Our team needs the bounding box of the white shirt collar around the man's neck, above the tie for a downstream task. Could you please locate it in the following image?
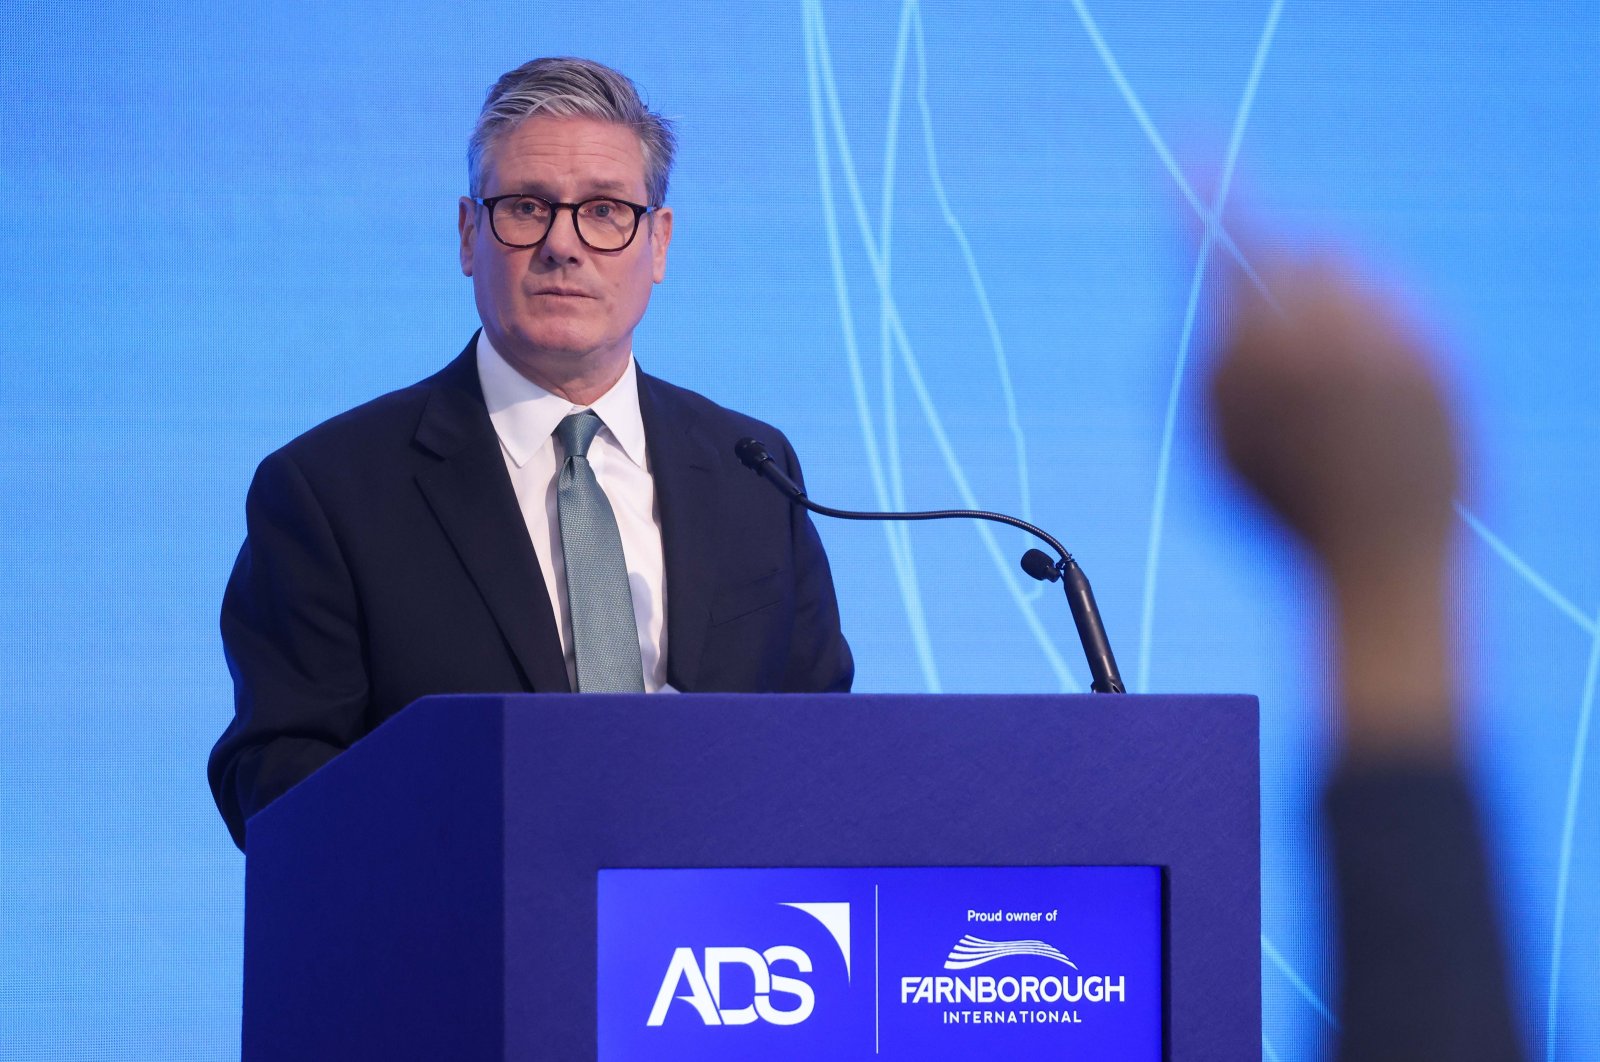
[477,331,646,469]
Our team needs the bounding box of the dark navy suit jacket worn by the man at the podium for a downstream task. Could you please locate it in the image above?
[210,339,854,848]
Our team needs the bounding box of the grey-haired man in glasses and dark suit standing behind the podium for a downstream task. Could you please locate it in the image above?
[210,59,853,848]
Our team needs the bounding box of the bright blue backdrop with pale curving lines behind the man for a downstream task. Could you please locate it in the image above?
[0,0,1600,1060]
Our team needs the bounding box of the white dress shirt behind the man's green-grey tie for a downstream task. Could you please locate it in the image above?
[478,333,670,693]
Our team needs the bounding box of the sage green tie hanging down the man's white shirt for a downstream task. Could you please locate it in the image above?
[555,409,645,693]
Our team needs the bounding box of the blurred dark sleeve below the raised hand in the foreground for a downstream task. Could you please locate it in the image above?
[1325,763,1522,1062]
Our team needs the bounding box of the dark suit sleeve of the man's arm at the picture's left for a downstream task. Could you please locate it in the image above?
[208,451,368,849]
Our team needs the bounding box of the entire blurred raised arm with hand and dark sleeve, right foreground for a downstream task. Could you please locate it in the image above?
[1211,264,1522,1062]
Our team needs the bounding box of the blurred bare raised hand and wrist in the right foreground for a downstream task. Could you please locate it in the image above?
[1210,259,1461,757]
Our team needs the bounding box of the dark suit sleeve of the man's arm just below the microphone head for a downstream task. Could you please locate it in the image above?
[778,437,856,693]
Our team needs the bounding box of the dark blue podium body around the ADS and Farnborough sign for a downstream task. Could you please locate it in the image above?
[243,694,1261,1060]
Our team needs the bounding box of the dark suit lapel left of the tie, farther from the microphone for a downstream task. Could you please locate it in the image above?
[416,336,571,693]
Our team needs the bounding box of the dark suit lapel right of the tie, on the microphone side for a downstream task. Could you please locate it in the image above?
[638,373,720,693]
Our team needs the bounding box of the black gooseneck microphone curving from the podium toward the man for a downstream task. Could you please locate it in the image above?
[733,438,1126,693]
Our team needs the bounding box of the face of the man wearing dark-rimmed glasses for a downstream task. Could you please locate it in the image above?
[459,117,672,385]
